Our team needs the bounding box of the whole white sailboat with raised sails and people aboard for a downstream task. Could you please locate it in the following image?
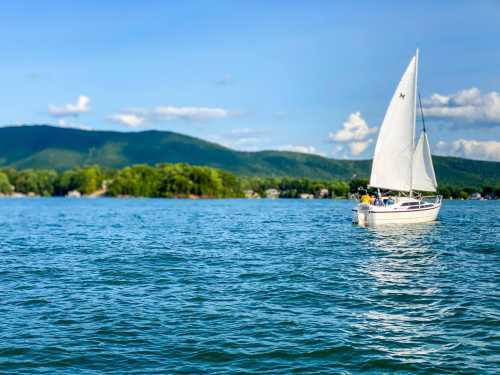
[353,49,442,226]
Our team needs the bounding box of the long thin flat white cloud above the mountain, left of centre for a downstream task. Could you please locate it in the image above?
[108,106,235,128]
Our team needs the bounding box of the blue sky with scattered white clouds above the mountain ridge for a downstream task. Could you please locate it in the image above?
[0,0,500,161]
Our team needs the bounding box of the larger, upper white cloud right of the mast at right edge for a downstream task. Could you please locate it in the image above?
[423,87,500,124]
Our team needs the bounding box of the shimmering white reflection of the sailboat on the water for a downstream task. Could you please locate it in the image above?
[357,223,440,360]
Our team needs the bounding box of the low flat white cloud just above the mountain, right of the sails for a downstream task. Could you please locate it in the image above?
[434,139,500,161]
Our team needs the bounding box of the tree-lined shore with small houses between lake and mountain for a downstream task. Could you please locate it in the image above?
[0,163,500,199]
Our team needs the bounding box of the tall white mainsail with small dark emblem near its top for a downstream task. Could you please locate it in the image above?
[370,51,418,191]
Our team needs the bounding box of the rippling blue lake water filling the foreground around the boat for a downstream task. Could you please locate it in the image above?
[0,199,500,374]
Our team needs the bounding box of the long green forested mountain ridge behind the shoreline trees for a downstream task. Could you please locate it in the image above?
[0,125,500,186]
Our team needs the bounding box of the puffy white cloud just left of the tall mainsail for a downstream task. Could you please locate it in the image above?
[328,112,377,158]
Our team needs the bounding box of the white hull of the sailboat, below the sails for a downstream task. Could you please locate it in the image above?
[352,204,441,226]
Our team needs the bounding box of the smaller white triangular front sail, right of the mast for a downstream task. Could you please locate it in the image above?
[412,131,437,191]
